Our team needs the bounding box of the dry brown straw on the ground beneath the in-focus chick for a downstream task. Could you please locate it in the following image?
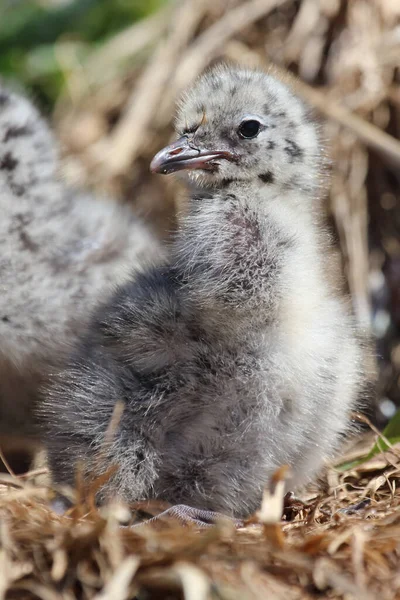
[0,441,400,600]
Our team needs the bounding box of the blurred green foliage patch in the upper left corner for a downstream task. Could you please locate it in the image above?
[0,0,166,110]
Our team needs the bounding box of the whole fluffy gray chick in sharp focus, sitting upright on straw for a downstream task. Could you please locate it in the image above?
[43,68,363,517]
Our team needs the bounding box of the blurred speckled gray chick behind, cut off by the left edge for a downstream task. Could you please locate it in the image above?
[0,83,159,450]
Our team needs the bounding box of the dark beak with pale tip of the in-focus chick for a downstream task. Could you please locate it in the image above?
[150,135,235,175]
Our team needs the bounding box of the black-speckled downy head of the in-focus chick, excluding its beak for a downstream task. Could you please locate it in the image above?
[159,66,321,193]
